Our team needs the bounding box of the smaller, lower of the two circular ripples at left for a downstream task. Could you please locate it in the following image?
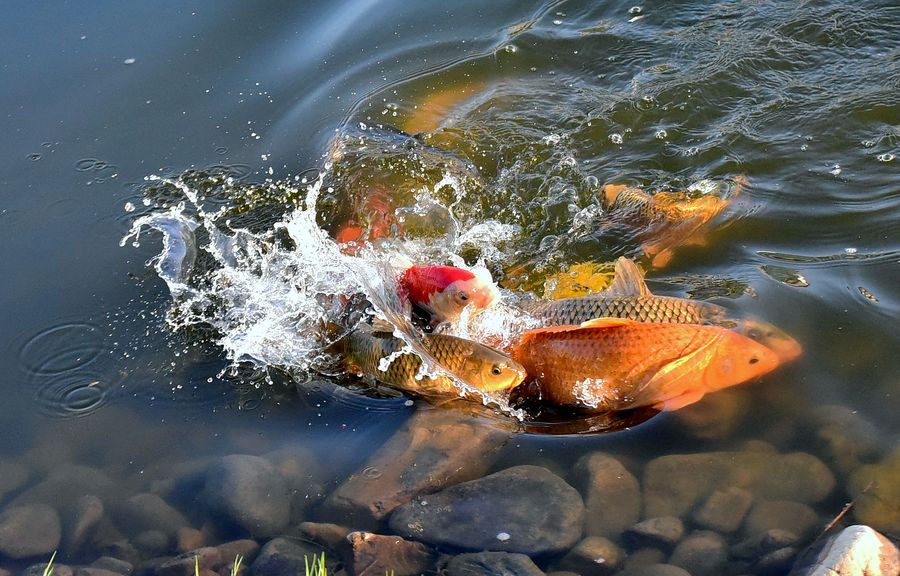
[35,372,109,417]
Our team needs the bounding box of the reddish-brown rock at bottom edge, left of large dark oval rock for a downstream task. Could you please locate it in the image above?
[347,532,437,576]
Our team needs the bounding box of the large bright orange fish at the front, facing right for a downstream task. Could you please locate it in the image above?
[512,318,779,410]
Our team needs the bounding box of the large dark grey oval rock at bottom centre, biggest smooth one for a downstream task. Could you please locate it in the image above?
[390,466,584,554]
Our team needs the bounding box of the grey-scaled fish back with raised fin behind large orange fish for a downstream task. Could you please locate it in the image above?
[522,257,726,326]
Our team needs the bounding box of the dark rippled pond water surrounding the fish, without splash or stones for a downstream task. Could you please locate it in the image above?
[0,0,900,567]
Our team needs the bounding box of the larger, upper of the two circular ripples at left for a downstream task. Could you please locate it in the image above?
[19,322,104,376]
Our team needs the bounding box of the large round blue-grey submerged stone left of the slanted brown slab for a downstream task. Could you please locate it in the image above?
[200,454,291,537]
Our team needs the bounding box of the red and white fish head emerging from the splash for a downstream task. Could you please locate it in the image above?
[398,266,500,325]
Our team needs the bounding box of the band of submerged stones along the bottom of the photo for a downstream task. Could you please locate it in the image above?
[0,406,900,576]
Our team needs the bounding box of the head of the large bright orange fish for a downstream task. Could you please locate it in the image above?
[703,329,781,391]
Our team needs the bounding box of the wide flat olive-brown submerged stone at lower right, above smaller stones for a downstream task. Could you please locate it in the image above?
[642,451,835,518]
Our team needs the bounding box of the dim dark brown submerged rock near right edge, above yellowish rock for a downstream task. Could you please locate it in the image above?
[810,405,880,474]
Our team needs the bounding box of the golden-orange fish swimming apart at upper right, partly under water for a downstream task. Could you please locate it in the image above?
[601,176,747,268]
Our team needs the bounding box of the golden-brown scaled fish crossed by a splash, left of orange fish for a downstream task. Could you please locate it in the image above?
[332,328,525,395]
